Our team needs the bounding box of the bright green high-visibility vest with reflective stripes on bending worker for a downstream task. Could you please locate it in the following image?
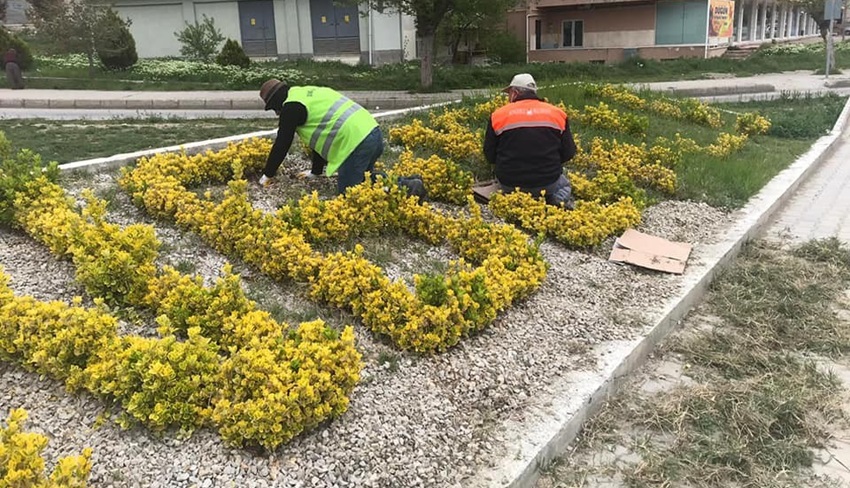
[286,86,378,176]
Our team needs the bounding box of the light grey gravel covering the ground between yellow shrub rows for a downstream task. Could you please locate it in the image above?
[0,170,729,487]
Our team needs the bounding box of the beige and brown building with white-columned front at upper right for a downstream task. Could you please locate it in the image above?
[508,0,819,63]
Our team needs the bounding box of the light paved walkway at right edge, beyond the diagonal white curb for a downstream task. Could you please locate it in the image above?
[766,126,850,244]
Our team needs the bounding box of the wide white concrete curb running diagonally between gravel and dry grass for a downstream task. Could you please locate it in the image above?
[480,95,850,488]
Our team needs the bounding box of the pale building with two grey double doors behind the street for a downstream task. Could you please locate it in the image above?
[114,0,416,64]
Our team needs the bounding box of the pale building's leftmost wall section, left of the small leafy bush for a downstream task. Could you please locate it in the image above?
[115,3,186,58]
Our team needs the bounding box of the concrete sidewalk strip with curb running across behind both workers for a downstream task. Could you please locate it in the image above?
[0,71,850,112]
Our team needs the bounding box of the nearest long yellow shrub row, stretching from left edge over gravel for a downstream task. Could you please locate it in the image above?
[0,262,362,448]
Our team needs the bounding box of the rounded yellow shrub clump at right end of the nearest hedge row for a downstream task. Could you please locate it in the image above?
[212,321,360,450]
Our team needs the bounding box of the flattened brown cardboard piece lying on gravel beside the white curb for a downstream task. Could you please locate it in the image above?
[608,229,692,274]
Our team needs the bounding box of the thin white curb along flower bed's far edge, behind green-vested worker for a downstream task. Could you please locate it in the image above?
[59,100,468,172]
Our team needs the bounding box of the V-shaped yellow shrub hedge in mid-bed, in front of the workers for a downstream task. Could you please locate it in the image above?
[122,143,546,352]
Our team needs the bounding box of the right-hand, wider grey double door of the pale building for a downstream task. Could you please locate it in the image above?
[310,0,360,55]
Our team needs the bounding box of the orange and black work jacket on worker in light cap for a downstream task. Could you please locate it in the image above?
[484,95,576,189]
